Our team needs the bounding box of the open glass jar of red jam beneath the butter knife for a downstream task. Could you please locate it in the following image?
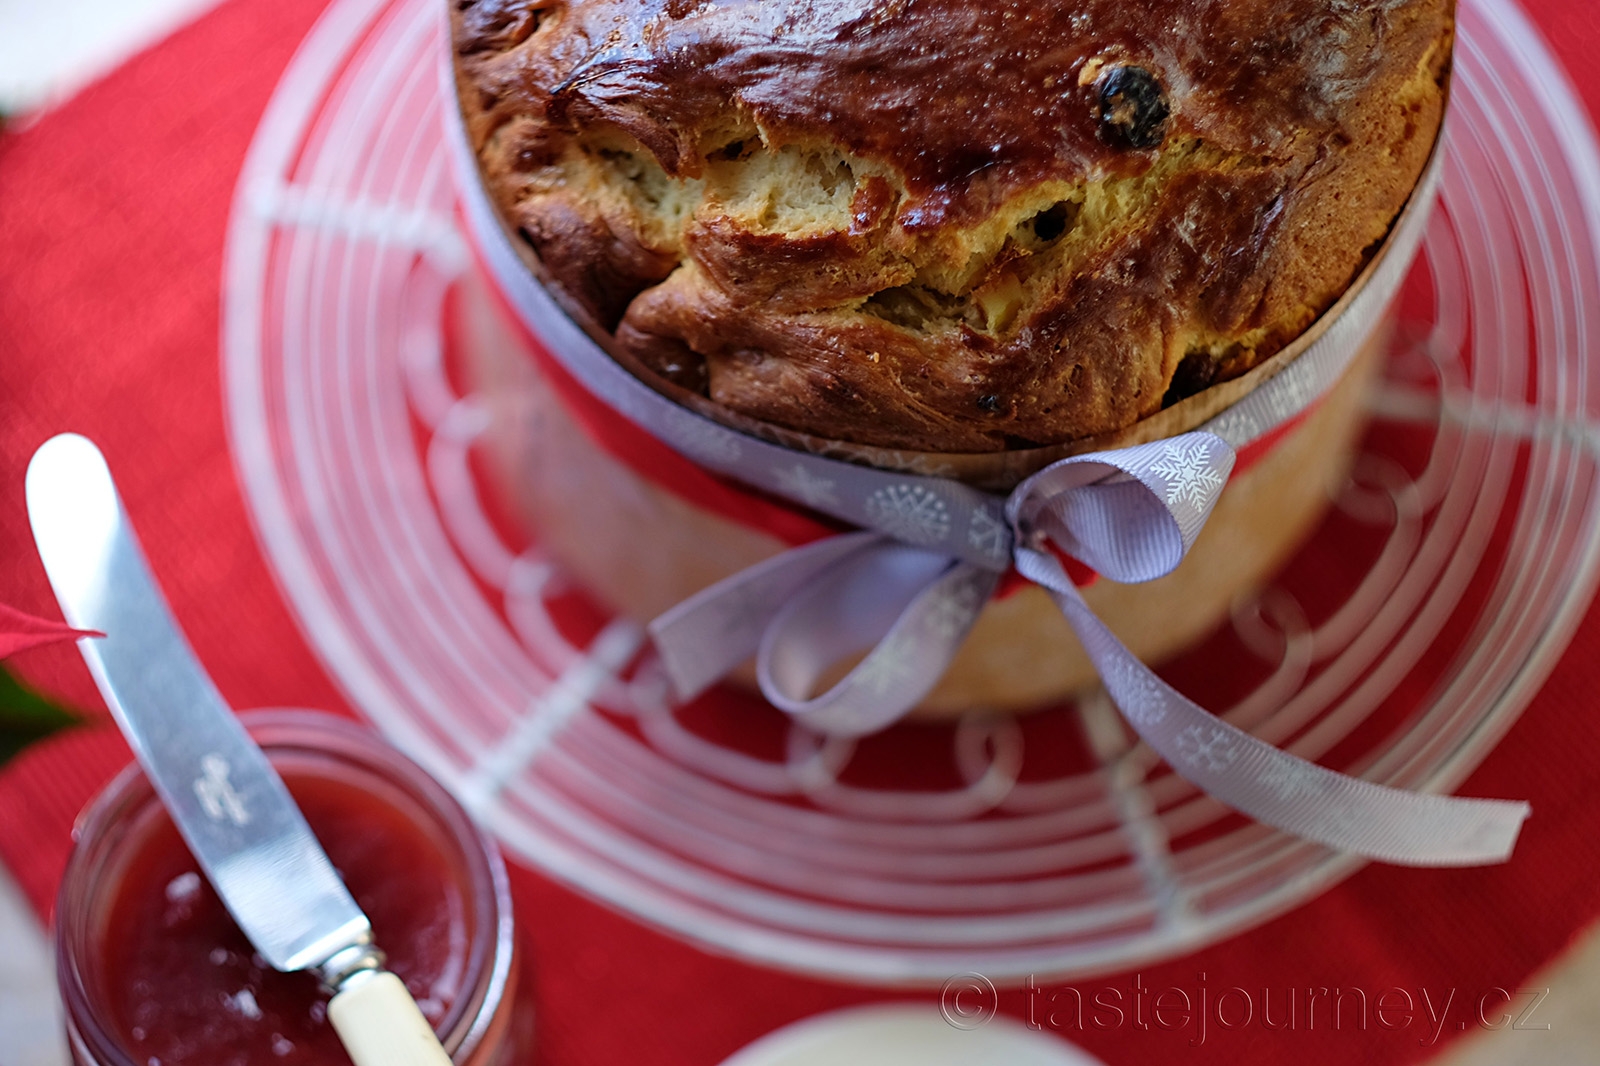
[56,711,531,1066]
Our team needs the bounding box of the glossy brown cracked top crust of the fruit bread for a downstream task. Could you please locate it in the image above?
[451,0,1454,453]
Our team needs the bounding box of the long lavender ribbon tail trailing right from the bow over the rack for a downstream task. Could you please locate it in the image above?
[1018,549,1531,866]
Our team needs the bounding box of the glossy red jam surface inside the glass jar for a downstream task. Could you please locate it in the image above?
[98,767,472,1066]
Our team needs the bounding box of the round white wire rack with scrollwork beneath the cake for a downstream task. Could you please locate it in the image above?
[224,0,1600,984]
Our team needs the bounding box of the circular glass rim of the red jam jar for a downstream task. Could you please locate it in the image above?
[54,709,515,1066]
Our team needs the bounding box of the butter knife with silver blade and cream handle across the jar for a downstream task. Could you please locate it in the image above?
[27,434,450,1066]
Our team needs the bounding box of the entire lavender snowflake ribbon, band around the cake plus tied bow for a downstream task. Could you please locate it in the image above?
[454,120,1530,866]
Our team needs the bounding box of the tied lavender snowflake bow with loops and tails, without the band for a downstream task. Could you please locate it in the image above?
[650,432,1530,866]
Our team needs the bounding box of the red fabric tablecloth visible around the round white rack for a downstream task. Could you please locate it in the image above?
[0,0,1600,1066]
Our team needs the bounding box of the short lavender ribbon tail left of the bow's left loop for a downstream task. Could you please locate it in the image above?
[648,533,883,701]
